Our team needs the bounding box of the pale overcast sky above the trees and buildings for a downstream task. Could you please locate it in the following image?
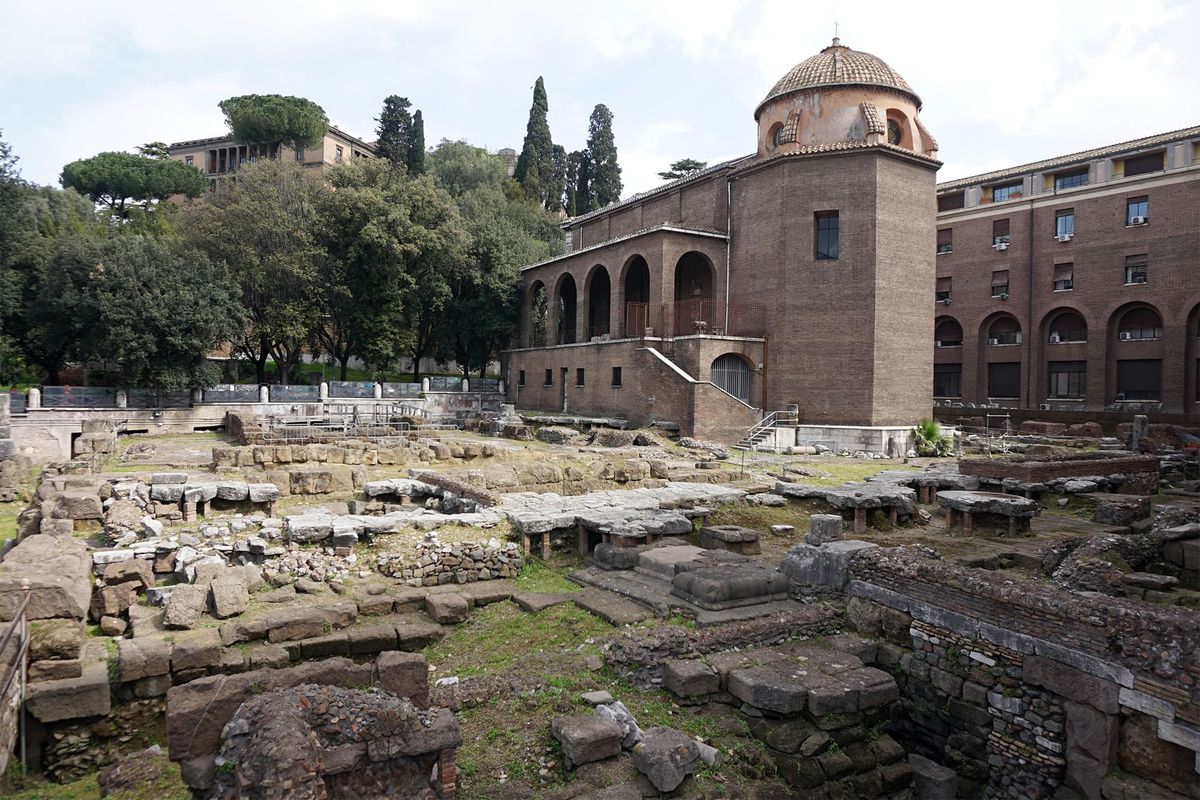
[0,0,1200,196]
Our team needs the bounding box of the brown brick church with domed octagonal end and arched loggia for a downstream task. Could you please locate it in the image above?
[505,40,940,451]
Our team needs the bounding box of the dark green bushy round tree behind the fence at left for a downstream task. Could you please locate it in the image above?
[80,236,241,391]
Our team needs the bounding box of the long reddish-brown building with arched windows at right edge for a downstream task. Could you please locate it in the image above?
[934,127,1200,414]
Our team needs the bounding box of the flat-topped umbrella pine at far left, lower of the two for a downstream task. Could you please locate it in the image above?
[60,152,209,221]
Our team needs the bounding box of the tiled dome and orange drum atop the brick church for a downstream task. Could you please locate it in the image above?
[755,38,937,158]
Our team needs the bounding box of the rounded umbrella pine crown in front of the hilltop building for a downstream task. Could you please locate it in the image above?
[220,95,329,154]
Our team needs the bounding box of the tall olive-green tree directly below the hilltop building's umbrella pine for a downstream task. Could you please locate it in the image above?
[184,160,328,384]
